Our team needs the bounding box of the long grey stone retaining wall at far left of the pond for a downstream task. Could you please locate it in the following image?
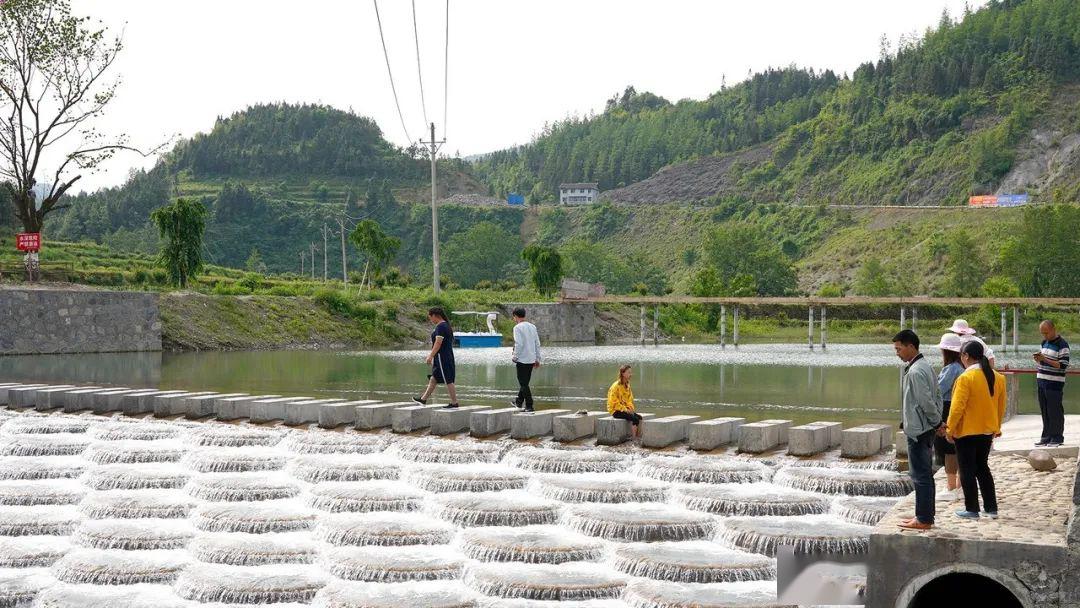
[0,288,161,354]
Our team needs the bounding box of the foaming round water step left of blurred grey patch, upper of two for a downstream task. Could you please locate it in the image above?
[615,541,777,583]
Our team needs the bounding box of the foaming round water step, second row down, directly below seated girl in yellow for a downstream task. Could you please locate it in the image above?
[537,473,669,502]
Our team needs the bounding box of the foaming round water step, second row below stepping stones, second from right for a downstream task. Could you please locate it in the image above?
[674,482,828,515]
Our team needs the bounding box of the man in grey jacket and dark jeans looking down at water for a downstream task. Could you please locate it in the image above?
[892,329,944,530]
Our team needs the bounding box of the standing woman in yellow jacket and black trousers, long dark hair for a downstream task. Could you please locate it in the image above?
[946,341,1005,519]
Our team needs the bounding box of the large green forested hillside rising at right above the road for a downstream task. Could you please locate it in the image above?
[475,0,1080,204]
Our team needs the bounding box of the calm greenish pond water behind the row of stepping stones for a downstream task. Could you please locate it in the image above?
[0,344,1067,423]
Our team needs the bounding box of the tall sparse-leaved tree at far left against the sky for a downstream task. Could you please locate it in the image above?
[0,0,164,232]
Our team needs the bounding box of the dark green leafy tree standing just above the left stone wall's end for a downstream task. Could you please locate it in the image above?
[150,199,206,288]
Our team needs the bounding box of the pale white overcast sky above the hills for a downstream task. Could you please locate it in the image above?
[63,0,985,190]
